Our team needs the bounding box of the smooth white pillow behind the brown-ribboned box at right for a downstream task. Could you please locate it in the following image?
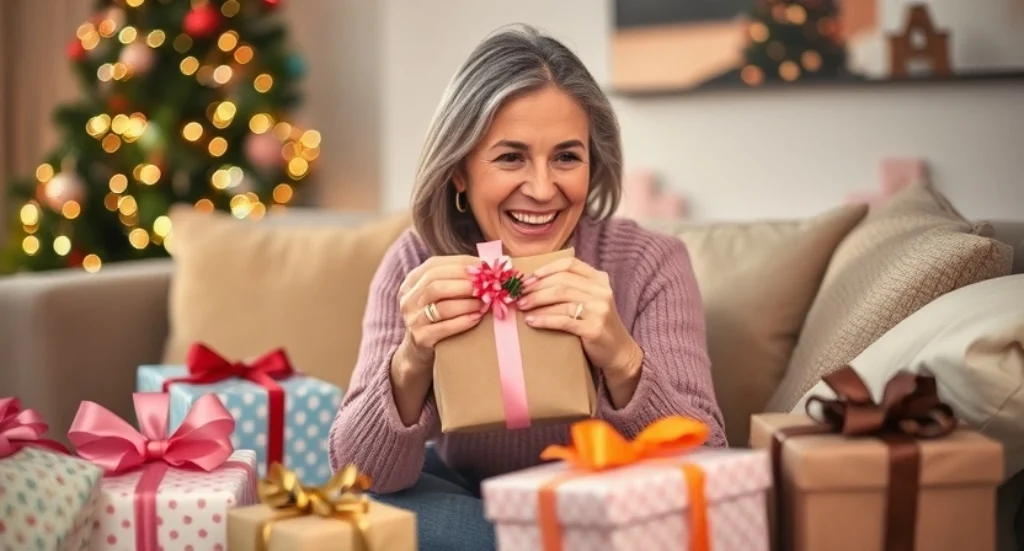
[793,273,1024,478]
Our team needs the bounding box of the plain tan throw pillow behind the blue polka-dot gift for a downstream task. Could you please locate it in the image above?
[164,208,411,388]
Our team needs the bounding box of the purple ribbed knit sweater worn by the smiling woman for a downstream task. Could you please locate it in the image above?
[330,214,726,494]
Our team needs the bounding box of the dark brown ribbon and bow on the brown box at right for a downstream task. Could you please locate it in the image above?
[771,366,956,551]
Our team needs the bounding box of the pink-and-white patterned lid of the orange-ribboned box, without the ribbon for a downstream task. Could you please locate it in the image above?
[482,450,771,526]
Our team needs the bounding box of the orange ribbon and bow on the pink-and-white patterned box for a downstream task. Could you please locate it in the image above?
[538,416,711,551]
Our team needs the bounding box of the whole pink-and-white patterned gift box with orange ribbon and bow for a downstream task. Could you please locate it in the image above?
[482,417,771,551]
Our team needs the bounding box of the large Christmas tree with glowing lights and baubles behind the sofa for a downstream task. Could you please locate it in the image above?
[3,0,321,271]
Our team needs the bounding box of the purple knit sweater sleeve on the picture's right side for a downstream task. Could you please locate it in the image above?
[598,236,726,448]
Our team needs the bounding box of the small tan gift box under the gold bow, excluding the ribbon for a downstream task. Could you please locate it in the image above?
[227,501,418,551]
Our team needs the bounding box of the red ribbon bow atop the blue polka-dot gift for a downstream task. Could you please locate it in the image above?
[163,337,295,392]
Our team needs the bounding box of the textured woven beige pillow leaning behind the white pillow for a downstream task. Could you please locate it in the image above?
[768,182,1013,412]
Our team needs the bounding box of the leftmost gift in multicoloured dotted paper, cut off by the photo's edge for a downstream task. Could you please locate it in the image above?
[0,397,102,551]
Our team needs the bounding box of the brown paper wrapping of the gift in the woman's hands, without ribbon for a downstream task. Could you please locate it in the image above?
[434,248,597,432]
